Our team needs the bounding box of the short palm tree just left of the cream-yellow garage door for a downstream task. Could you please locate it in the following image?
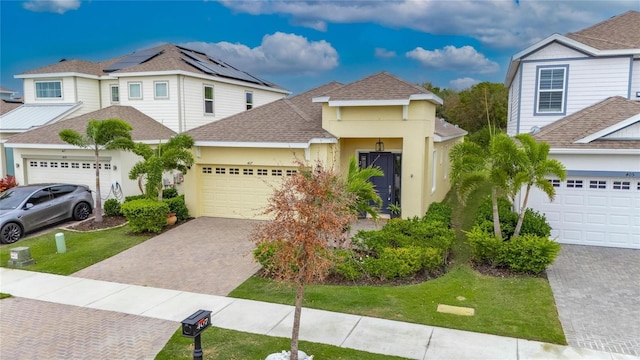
[129,134,194,201]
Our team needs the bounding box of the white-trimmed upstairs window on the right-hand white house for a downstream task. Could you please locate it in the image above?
[536,66,569,114]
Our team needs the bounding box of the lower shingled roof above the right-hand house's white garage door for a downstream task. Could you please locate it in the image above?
[534,96,640,149]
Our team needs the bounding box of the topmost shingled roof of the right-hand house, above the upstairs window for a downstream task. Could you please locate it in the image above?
[565,10,640,50]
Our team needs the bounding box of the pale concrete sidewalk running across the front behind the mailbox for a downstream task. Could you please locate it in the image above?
[0,268,639,360]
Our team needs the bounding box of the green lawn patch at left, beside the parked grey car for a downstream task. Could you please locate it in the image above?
[0,225,151,275]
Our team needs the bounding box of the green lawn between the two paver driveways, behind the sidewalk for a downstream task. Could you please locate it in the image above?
[229,187,566,344]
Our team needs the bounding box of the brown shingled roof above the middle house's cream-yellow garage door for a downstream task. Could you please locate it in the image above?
[187,82,343,143]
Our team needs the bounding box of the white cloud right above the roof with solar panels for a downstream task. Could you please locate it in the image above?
[183,32,338,75]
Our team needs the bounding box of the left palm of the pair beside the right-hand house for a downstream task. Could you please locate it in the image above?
[450,133,522,239]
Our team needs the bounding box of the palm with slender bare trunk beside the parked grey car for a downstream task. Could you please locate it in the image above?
[58,119,134,222]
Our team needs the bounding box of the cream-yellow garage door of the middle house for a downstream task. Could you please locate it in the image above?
[198,165,296,219]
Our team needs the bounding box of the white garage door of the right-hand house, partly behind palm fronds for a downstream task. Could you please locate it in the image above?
[529,177,640,249]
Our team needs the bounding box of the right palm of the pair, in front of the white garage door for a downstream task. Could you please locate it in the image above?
[513,134,567,237]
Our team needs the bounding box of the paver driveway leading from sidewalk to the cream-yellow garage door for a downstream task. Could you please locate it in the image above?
[73,217,260,296]
